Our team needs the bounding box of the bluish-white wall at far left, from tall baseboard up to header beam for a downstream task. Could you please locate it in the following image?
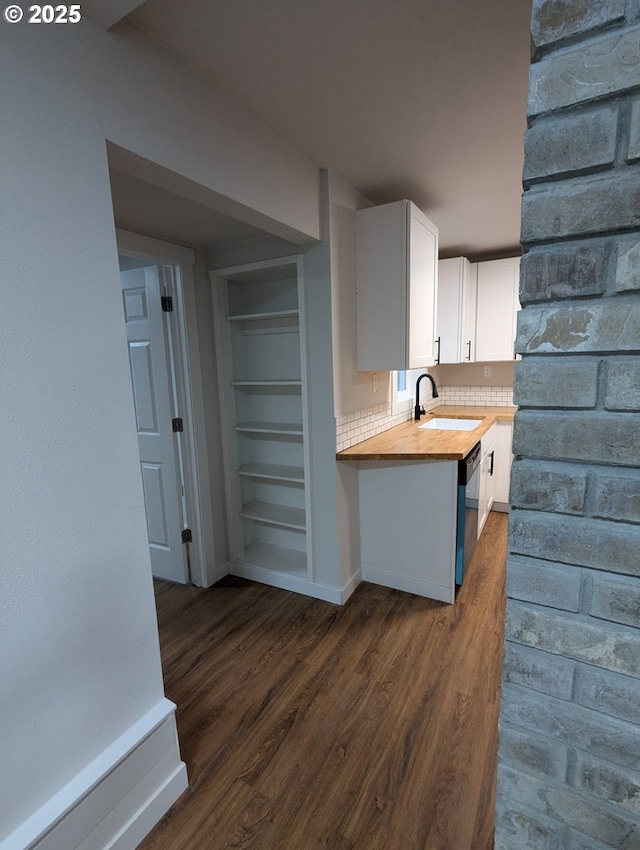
[0,19,168,832]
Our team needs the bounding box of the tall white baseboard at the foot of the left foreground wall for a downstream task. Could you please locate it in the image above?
[0,699,188,850]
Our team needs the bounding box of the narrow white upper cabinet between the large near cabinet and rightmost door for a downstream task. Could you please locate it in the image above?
[436,257,476,363]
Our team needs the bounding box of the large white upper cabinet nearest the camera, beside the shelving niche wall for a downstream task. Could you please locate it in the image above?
[356,201,438,372]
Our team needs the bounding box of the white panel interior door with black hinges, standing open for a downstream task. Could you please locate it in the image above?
[120,266,188,584]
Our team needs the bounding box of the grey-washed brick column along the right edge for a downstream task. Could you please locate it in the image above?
[495,0,640,850]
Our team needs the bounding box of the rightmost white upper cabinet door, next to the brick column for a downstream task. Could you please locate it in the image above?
[476,252,520,361]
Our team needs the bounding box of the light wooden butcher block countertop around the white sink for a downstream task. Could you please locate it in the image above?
[336,404,516,460]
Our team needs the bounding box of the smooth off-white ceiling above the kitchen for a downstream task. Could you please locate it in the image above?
[113,0,531,259]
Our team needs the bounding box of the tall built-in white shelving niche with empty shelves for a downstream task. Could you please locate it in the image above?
[211,257,313,592]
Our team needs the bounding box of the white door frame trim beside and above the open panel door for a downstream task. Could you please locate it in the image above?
[116,227,219,587]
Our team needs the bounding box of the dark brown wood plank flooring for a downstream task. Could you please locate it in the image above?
[141,513,507,850]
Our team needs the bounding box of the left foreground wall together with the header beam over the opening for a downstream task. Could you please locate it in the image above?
[0,16,318,835]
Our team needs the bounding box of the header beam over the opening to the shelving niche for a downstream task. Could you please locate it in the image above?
[94,24,319,243]
